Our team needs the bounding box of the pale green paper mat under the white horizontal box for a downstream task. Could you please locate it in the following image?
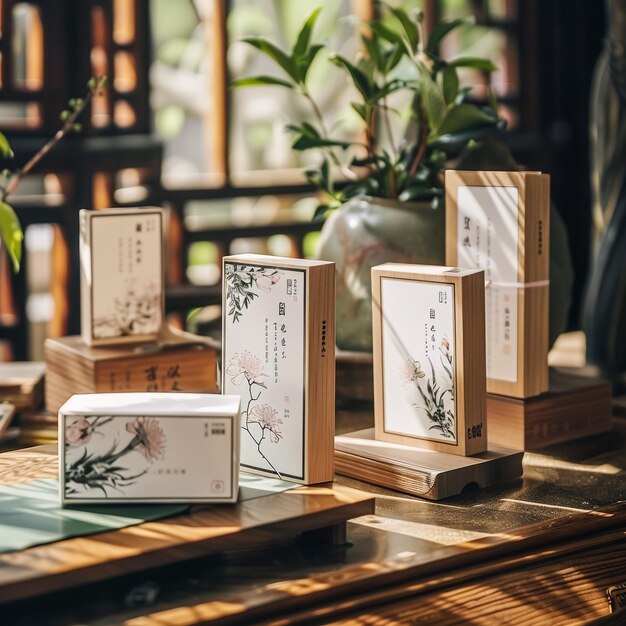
[0,473,298,553]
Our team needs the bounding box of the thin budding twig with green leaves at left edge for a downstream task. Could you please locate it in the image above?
[0,76,107,272]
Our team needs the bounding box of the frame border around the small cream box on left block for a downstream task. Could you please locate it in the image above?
[80,207,165,346]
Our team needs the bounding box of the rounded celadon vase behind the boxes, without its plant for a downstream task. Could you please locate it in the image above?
[316,196,445,352]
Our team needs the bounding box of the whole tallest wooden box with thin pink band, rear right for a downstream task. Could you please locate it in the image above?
[446,171,549,397]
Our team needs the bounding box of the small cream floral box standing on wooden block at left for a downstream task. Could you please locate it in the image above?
[80,208,163,345]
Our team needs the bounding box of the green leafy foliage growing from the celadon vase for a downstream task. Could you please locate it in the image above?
[231,3,504,216]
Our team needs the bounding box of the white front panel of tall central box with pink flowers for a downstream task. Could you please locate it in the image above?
[223,262,306,480]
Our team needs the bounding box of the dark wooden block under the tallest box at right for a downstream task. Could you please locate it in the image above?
[487,369,612,450]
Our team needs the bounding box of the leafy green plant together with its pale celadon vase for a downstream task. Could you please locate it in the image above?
[232,3,568,350]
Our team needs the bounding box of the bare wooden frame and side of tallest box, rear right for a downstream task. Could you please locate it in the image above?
[445,170,550,398]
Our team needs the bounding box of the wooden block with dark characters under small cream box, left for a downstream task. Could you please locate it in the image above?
[44,331,218,413]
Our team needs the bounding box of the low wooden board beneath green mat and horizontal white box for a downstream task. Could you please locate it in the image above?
[0,449,374,604]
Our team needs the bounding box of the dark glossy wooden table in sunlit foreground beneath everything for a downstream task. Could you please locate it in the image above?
[0,420,626,626]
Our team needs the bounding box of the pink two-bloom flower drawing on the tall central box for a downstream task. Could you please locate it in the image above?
[226,350,283,478]
